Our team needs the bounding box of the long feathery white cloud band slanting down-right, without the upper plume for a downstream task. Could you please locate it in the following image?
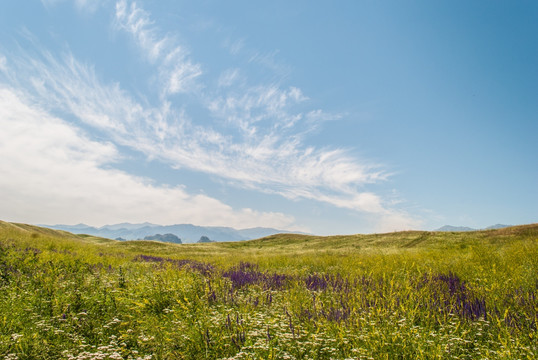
[1,47,386,217]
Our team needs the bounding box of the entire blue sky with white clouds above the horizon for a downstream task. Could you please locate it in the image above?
[0,0,538,235]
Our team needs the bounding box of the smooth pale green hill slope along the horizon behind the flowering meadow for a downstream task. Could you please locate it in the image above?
[0,222,538,259]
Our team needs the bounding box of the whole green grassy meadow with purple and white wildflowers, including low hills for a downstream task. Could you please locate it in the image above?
[0,222,538,360]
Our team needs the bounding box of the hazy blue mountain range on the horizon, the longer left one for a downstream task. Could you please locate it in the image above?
[40,222,302,243]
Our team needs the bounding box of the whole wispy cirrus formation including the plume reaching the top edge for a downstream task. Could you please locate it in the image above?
[0,0,418,231]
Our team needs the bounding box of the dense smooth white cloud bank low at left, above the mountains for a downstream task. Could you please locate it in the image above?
[0,87,294,228]
